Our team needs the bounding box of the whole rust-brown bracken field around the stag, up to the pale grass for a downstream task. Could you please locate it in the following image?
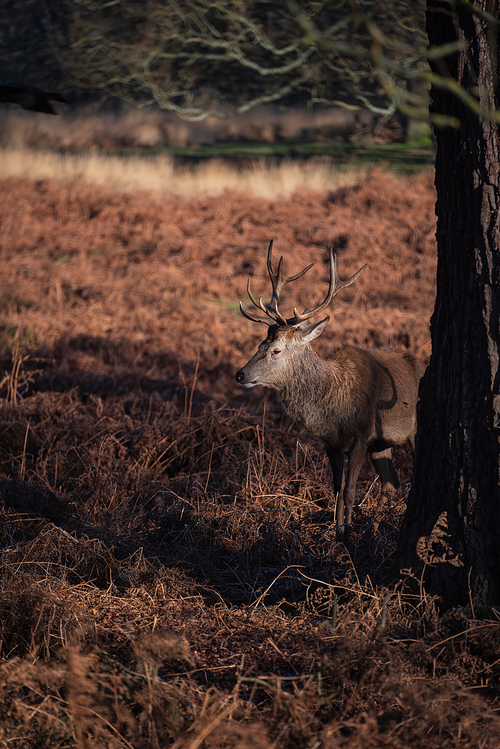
[0,164,500,749]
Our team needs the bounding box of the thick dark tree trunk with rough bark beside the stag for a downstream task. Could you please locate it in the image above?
[395,0,500,615]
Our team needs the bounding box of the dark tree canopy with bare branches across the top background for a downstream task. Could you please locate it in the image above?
[4,0,500,127]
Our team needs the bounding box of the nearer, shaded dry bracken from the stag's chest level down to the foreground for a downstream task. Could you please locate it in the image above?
[0,360,500,748]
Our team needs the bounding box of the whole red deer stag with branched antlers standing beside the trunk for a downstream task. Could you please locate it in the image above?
[236,240,424,527]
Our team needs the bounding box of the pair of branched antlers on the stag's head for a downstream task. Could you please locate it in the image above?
[240,239,367,325]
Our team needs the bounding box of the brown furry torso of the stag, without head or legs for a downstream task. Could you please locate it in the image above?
[281,346,423,452]
